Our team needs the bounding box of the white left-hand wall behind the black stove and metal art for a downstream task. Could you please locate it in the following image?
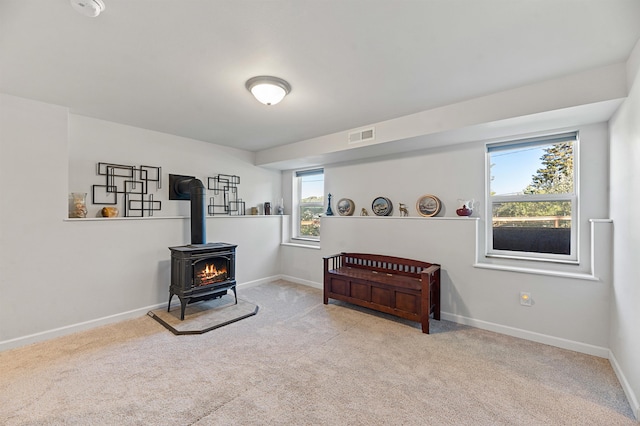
[0,95,282,349]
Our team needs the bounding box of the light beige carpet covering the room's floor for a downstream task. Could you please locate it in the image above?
[0,281,637,426]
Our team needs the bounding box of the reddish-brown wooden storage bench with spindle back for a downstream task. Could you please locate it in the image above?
[323,253,440,334]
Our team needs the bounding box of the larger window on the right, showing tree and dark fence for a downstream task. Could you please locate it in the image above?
[487,133,578,263]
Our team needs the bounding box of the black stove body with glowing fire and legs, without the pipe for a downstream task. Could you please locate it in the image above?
[167,243,238,320]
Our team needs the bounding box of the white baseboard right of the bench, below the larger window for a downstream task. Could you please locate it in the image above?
[440,312,609,358]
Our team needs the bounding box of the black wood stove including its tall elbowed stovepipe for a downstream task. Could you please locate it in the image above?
[167,175,238,320]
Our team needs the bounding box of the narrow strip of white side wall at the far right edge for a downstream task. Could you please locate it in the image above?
[610,42,640,419]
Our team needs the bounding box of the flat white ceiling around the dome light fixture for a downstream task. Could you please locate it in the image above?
[0,0,640,151]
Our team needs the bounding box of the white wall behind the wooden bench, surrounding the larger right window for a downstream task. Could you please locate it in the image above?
[282,123,610,357]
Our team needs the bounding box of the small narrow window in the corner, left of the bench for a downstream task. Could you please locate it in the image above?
[293,169,324,240]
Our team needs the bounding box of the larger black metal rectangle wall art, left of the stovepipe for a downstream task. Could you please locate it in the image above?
[91,162,162,217]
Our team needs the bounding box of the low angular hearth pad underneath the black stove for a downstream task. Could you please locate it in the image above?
[147,294,258,335]
